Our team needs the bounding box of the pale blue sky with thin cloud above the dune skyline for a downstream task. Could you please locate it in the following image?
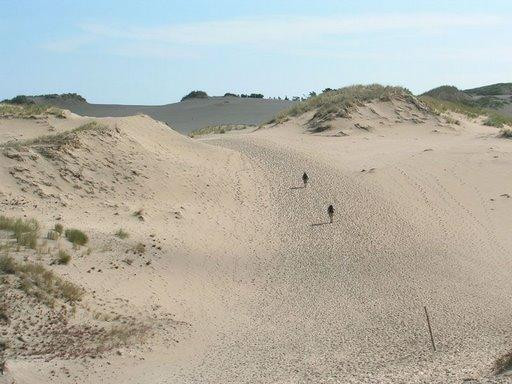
[0,0,512,104]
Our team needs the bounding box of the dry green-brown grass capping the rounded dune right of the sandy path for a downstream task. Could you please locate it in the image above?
[269,84,415,123]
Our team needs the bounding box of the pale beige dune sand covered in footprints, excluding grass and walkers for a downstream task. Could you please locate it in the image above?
[0,97,512,384]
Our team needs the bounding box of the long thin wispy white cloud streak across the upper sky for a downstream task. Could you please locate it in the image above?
[82,14,505,45]
